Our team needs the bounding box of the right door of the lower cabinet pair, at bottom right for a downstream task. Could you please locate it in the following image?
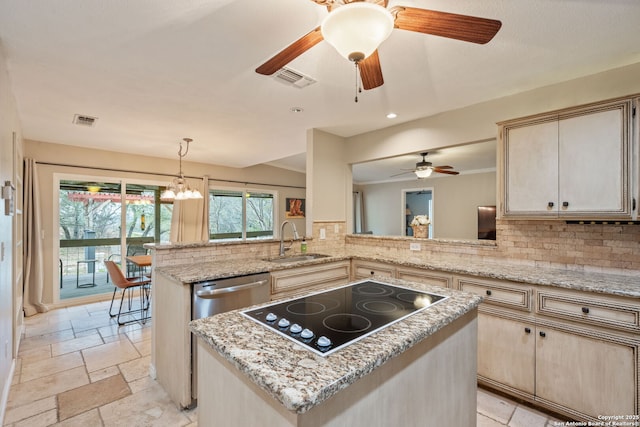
[536,326,639,418]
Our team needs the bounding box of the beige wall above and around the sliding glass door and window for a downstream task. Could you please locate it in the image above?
[24,140,306,304]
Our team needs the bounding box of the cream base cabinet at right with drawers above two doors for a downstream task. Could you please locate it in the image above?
[454,276,640,421]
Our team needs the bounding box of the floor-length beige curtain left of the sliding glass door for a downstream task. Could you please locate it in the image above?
[23,159,49,316]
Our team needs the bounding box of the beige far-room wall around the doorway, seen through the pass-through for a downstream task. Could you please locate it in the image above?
[359,172,496,240]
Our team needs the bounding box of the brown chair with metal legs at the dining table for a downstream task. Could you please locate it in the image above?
[104,261,151,325]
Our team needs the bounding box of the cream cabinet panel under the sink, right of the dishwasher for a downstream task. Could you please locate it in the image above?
[271,260,351,299]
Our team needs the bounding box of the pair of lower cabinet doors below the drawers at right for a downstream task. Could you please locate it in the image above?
[478,312,640,421]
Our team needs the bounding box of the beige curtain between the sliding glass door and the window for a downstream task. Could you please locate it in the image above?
[170,176,209,243]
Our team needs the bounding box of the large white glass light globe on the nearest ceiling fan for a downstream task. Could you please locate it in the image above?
[320,2,393,60]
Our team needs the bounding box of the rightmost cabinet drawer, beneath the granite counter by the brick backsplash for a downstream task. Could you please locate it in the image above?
[536,291,640,331]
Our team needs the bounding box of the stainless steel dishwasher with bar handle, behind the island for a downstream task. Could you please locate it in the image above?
[191,273,271,399]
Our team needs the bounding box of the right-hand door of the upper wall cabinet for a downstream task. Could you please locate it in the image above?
[558,105,628,214]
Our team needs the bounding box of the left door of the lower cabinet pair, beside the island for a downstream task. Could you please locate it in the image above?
[478,312,536,395]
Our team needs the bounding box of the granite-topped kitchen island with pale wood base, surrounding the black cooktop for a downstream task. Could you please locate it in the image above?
[190,279,482,426]
